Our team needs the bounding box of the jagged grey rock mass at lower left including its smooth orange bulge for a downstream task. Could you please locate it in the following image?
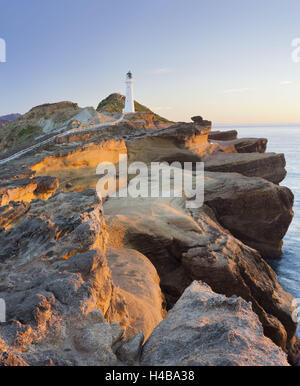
[0,189,166,366]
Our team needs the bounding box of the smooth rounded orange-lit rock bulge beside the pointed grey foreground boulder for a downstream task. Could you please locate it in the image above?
[107,248,166,339]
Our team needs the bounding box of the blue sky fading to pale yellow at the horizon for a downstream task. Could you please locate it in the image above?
[0,0,300,124]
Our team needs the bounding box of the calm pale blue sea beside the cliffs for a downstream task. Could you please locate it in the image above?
[214,124,300,337]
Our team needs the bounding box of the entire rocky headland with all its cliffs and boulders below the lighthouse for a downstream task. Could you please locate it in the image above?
[0,102,299,366]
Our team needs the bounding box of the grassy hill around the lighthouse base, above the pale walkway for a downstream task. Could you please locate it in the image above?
[0,98,172,155]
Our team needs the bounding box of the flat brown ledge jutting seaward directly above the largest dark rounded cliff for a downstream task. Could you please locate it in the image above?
[205,153,286,184]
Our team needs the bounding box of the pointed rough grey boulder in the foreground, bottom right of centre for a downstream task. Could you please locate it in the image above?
[141,282,288,366]
